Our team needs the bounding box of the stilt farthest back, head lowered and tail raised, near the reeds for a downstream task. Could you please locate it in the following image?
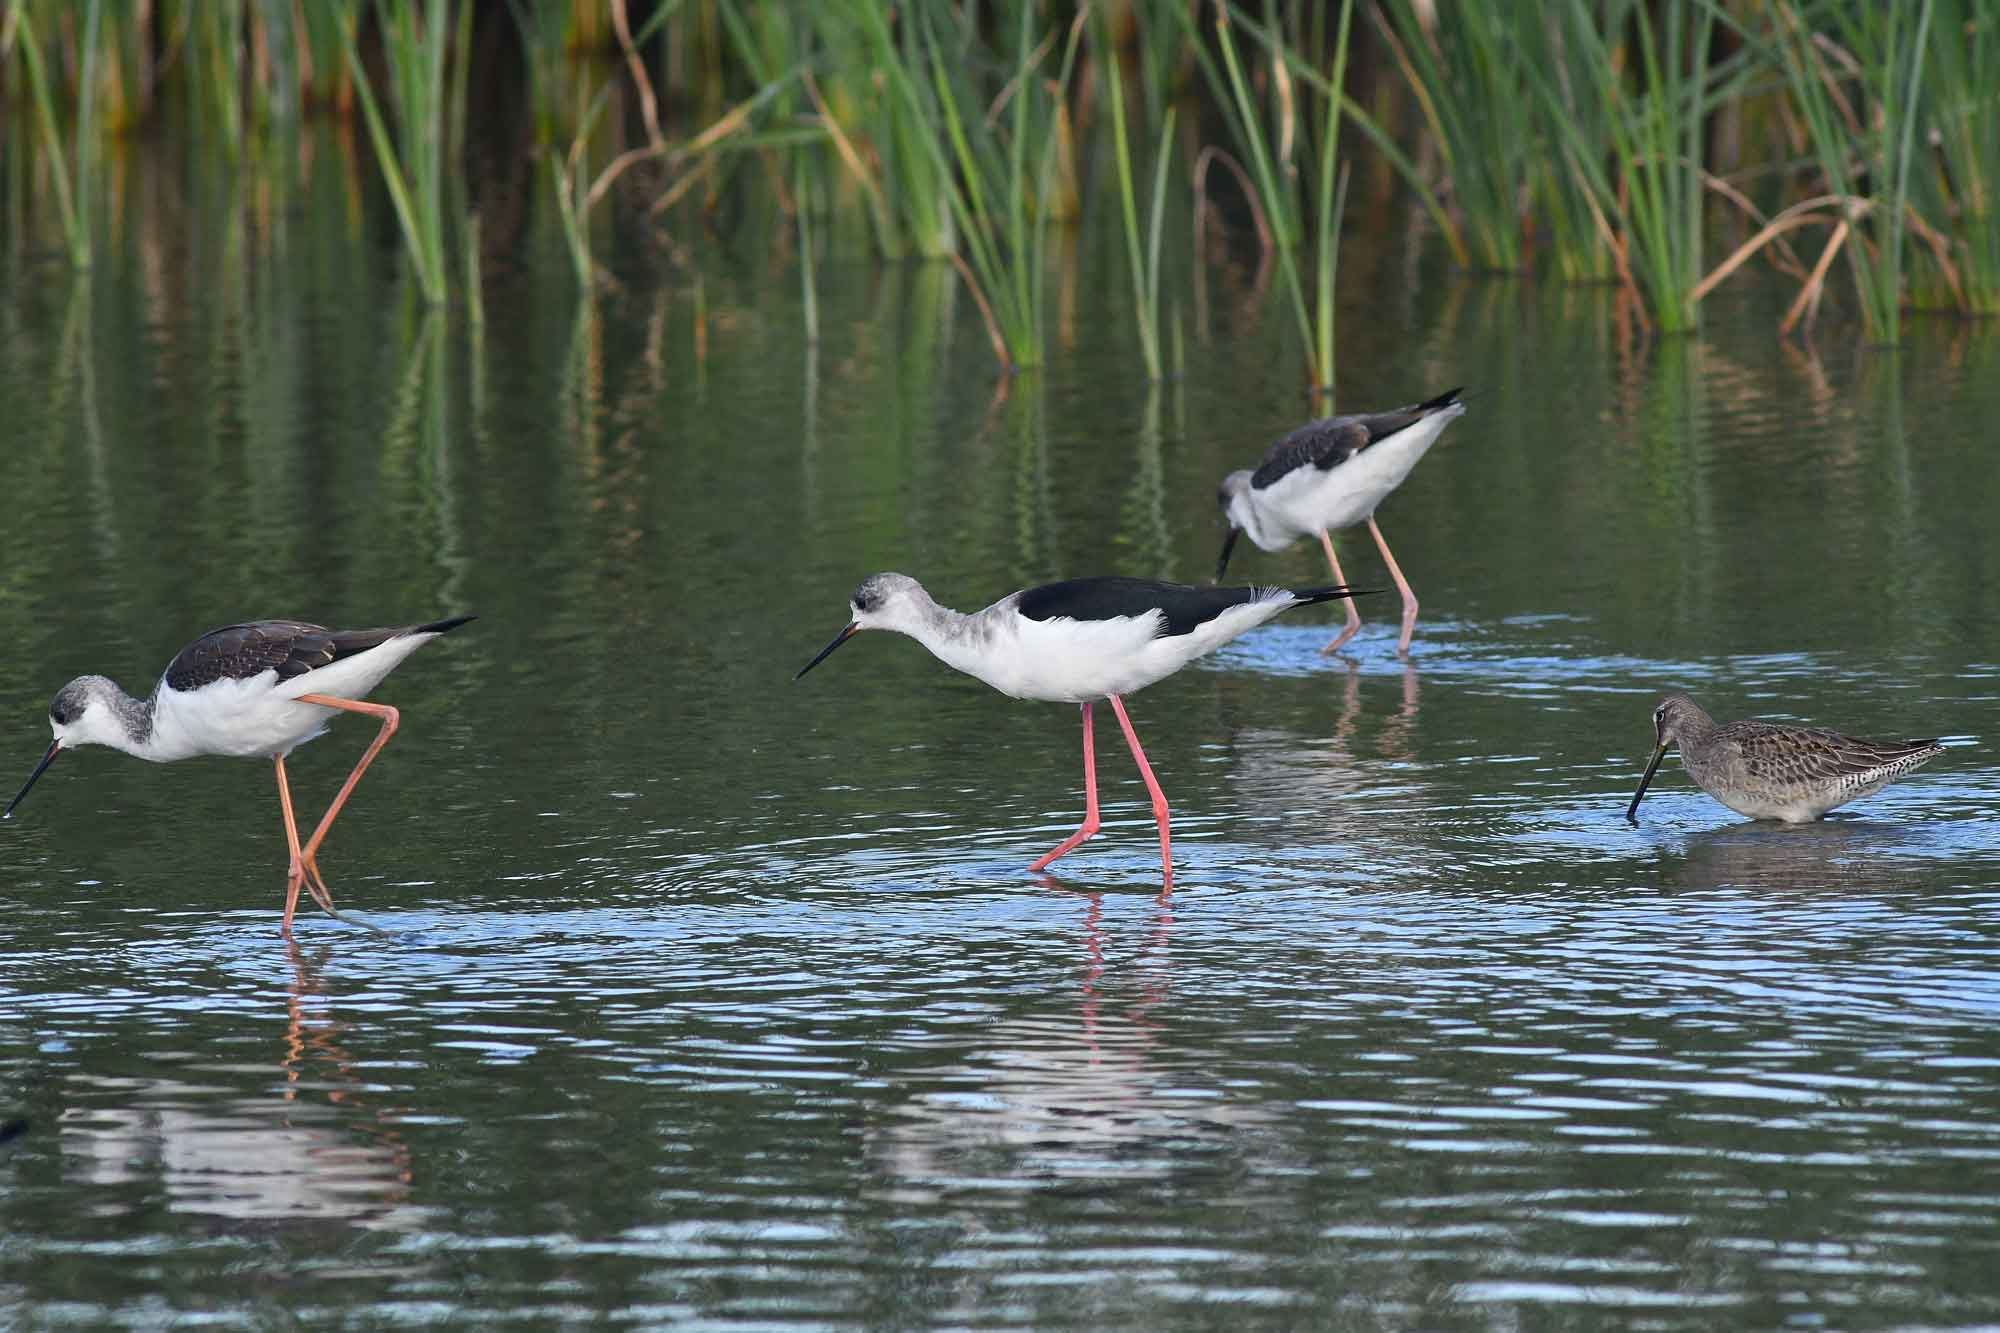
[1216,388,1466,656]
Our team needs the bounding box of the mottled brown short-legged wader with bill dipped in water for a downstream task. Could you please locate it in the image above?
[1626,695,1944,825]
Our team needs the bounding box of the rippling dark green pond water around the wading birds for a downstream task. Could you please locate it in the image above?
[0,140,2000,1329]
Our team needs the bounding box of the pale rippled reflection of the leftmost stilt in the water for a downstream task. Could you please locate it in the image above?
[58,939,428,1231]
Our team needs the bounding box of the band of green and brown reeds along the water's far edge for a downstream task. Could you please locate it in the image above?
[0,0,2000,348]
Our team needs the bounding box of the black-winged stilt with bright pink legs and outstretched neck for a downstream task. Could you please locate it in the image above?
[792,574,1354,889]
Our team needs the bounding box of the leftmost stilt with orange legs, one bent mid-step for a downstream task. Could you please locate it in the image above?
[0,616,474,935]
